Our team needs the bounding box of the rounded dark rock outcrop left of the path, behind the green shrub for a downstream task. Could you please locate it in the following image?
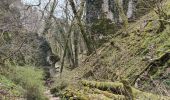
[10,33,52,66]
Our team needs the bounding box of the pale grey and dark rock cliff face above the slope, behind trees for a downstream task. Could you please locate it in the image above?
[86,0,135,23]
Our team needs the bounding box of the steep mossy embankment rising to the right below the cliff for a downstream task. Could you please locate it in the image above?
[53,1,170,100]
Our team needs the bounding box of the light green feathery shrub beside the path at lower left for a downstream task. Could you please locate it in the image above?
[1,64,46,100]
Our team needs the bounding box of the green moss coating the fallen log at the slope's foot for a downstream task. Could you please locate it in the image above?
[82,80,170,100]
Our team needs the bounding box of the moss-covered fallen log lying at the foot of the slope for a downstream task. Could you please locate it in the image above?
[81,80,170,100]
